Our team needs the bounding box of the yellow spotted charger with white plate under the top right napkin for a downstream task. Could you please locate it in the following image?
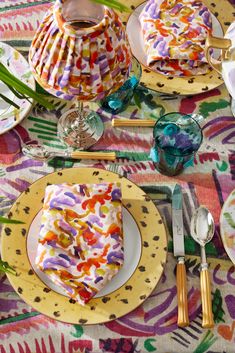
[120,0,234,95]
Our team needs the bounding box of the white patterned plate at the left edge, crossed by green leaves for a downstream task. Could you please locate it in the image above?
[0,42,35,135]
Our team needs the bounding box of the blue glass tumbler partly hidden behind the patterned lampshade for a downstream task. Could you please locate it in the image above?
[98,57,142,114]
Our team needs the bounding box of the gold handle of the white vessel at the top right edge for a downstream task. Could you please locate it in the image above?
[205,36,232,74]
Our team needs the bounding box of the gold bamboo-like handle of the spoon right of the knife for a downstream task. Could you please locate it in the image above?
[200,268,215,328]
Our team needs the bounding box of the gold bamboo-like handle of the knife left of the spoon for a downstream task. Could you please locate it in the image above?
[176,262,189,327]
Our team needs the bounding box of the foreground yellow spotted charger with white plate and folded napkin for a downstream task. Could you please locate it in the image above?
[1,168,167,324]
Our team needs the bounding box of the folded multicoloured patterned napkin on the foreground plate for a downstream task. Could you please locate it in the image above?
[36,183,123,304]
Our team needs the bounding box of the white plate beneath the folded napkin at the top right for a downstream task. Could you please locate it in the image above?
[126,2,223,74]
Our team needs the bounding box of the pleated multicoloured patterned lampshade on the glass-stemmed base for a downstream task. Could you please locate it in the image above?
[29,0,131,100]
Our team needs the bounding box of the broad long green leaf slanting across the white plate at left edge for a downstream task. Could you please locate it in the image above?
[0,63,55,109]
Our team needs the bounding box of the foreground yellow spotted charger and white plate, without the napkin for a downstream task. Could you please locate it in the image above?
[1,168,167,324]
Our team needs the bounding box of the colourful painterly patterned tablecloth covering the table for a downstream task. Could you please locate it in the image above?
[0,0,235,353]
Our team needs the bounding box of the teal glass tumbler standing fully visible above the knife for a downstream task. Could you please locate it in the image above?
[150,113,203,176]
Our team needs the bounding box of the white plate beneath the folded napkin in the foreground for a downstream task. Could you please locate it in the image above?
[27,208,142,298]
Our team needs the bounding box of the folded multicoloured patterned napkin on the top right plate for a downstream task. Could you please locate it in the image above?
[140,0,212,76]
